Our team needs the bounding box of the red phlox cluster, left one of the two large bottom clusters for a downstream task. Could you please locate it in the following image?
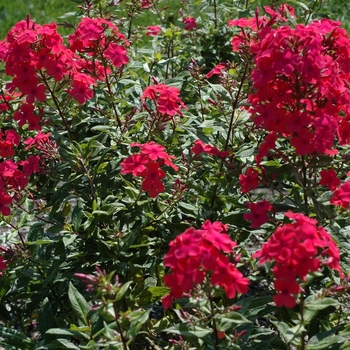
[162,220,249,309]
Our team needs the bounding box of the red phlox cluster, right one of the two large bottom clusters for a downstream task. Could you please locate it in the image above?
[253,212,343,308]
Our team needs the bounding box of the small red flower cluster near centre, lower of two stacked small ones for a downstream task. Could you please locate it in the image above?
[121,141,178,198]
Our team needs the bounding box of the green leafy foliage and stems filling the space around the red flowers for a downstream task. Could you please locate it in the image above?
[0,0,350,350]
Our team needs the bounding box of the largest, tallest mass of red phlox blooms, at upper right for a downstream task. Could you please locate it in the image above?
[231,11,350,159]
